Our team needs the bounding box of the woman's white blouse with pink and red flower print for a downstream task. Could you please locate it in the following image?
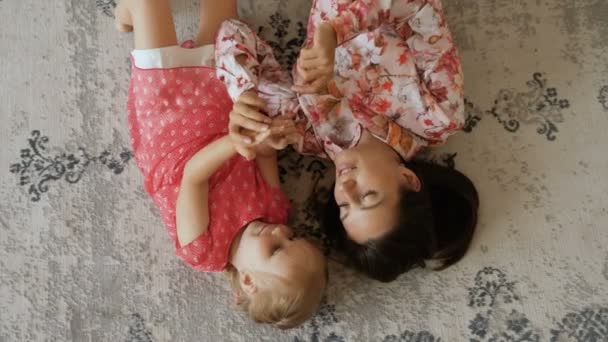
[294,0,465,159]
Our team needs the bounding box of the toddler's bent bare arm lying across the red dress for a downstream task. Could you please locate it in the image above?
[175,136,236,246]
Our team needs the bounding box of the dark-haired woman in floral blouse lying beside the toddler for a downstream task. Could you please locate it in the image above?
[235,0,477,281]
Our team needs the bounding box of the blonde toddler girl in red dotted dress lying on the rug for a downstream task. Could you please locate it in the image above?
[116,0,326,328]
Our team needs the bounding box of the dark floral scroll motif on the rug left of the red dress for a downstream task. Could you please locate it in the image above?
[10,130,133,202]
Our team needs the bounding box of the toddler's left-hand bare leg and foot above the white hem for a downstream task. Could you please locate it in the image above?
[115,0,178,49]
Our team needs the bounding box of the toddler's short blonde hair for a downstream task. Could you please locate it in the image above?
[226,265,327,329]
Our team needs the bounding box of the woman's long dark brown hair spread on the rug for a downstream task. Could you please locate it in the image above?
[323,162,479,282]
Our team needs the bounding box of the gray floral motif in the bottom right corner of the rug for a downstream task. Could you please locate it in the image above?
[551,307,608,342]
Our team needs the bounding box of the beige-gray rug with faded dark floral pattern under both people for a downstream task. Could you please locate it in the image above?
[0,0,608,342]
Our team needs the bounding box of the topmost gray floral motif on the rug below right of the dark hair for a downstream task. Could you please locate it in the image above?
[468,267,519,307]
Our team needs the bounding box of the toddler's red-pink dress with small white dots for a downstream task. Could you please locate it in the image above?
[127,21,289,272]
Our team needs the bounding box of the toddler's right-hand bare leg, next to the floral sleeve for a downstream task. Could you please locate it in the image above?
[196,0,238,46]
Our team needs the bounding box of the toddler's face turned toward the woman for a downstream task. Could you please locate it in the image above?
[231,221,325,278]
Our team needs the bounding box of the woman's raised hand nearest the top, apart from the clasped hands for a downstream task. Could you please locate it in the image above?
[293,23,337,94]
